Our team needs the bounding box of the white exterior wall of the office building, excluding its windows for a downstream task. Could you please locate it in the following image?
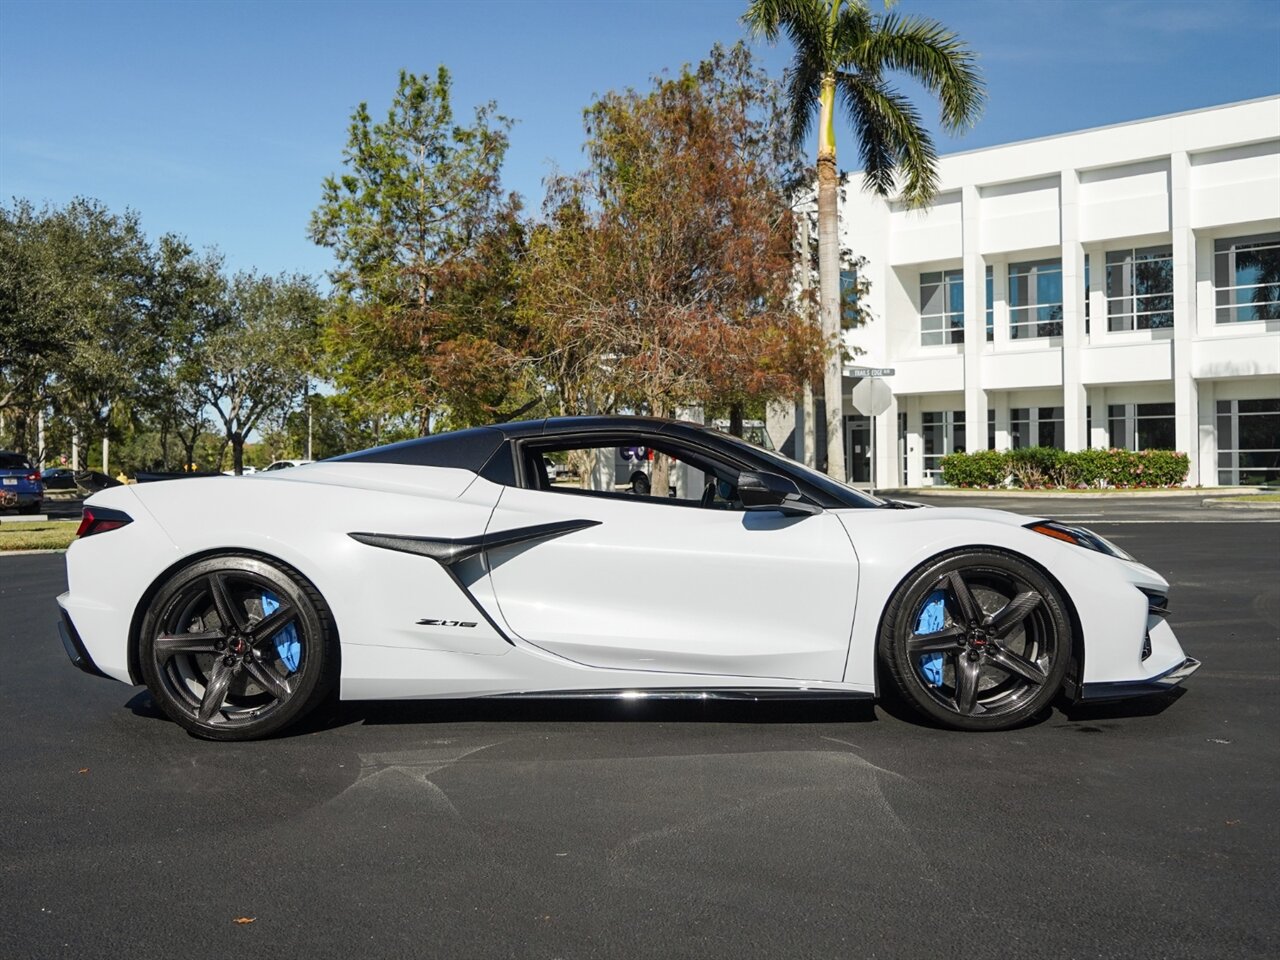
[841,97,1280,485]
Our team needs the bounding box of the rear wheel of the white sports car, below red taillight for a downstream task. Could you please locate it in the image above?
[138,554,338,740]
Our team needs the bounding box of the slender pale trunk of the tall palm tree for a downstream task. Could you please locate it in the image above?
[818,76,845,480]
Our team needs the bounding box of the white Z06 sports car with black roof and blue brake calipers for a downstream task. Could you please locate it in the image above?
[58,417,1199,740]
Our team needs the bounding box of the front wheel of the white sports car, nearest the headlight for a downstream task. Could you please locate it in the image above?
[879,548,1071,730]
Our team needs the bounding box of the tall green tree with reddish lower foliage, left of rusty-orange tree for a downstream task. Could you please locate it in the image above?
[310,67,522,434]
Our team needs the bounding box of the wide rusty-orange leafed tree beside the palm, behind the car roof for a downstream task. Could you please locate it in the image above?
[525,45,824,489]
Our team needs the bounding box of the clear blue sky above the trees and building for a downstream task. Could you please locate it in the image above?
[0,0,1280,275]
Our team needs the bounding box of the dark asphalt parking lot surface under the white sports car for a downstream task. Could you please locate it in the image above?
[0,500,1280,957]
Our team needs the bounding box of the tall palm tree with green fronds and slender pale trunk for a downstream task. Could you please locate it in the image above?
[742,0,986,480]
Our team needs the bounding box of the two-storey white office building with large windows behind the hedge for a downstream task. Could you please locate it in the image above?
[771,97,1280,486]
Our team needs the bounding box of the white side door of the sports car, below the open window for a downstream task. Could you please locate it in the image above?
[489,435,858,681]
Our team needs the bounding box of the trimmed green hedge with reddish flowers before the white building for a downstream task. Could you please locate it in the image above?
[942,447,1190,489]
